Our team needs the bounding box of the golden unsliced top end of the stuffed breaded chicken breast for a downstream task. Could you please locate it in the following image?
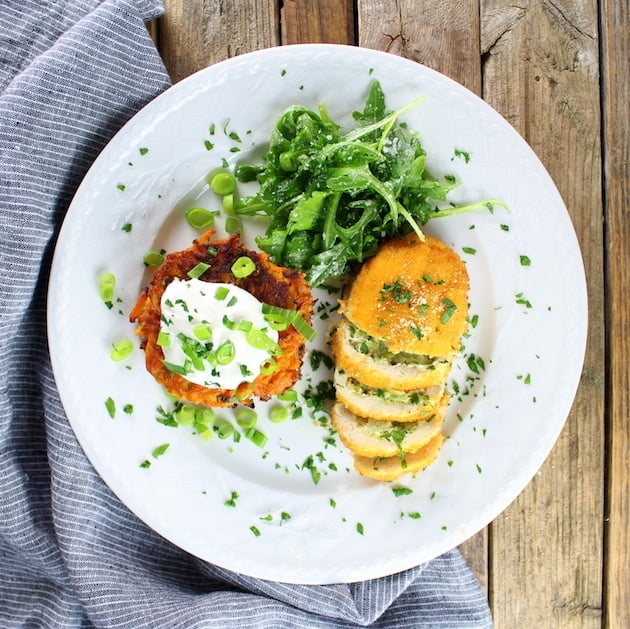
[340,234,469,356]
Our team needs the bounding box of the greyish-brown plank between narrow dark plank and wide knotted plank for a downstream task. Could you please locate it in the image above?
[357,0,488,593]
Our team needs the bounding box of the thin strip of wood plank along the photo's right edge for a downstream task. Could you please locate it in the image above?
[601,0,630,629]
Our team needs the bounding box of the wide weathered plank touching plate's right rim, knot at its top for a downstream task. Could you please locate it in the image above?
[481,0,605,628]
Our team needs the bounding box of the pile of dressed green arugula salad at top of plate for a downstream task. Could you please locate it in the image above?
[234,81,503,287]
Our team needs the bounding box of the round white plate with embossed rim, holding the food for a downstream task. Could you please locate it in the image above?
[49,45,587,584]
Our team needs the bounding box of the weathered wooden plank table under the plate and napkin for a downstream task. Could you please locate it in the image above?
[151,0,630,629]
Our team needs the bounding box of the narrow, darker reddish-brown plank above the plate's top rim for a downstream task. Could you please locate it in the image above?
[280,0,354,44]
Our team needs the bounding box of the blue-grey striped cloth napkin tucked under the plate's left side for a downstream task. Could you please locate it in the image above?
[0,0,492,629]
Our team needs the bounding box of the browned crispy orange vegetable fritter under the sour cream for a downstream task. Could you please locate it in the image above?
[129,230,313,406]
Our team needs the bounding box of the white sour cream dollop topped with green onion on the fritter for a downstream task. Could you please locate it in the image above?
[158,278,278,389]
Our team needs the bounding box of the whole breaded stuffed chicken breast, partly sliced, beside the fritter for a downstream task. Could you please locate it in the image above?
[331,234,469,481]
